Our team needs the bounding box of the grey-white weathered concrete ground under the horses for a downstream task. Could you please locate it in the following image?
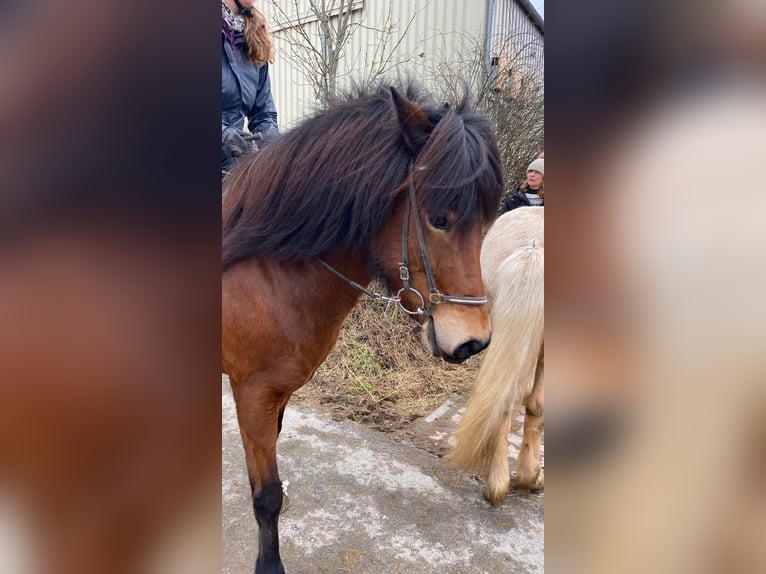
[222,382,544,574]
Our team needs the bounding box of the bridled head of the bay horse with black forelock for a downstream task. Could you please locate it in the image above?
[376,89,502,363]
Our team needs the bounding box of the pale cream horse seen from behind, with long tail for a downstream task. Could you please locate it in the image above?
[450,207,544,505]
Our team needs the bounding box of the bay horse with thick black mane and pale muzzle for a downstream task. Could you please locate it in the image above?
[222,82,502,574]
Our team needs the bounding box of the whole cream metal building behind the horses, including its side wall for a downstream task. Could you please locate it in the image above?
[259,0,544,130]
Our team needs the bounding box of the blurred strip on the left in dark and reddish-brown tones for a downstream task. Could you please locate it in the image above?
[0,0,220,574]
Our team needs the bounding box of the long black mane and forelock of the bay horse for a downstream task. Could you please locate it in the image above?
[223,78,503,270]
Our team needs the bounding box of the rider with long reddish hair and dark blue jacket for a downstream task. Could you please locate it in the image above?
[221,0,279,170]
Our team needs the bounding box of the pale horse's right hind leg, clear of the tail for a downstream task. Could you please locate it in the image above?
[515,356,545,490]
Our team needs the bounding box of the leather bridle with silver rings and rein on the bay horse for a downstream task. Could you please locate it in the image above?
[317,164,487,335]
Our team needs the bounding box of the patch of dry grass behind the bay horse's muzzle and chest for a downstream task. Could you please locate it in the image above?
[294,290,479,431]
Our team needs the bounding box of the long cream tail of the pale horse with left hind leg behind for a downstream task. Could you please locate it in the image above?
[449,243,545,504]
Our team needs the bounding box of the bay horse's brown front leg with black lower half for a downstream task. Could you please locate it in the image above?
[232,377,289,574]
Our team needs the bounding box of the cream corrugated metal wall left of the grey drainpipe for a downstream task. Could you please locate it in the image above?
[256,0,488,131]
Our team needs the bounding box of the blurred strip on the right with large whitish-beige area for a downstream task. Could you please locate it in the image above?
[546,2,766,574]
